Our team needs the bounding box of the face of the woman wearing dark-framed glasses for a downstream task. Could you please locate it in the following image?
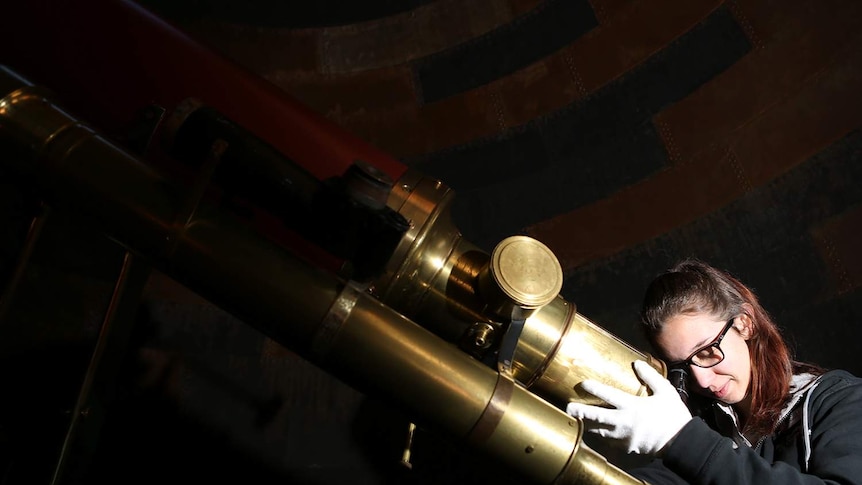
[656,313,751,412]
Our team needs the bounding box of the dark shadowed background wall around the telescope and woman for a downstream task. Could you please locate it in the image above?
[0,0,862,484]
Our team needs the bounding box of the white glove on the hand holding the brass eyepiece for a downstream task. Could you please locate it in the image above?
[566,360,691,455]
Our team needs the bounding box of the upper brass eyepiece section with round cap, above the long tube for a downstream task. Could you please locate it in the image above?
[382,171,667,407]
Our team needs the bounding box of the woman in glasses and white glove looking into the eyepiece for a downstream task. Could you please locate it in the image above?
[567,260,862,485]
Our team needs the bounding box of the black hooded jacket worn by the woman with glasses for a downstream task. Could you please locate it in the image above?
[629,370,862,485]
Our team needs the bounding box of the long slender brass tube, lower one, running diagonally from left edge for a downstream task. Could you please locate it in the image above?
[0,68,641,484]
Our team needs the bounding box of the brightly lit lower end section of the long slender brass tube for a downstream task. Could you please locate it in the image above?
[322,295,641,484]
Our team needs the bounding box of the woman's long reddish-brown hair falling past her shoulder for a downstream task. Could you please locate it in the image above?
[641,259,823,436]
